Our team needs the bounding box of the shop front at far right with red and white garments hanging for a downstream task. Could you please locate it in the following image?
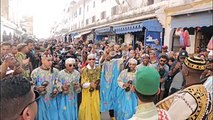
[171,10,213,53]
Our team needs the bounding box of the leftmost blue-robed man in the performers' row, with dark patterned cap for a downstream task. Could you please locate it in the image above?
[31,52,59,120]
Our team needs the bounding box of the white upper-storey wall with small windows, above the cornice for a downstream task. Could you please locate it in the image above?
[66,0,164,31]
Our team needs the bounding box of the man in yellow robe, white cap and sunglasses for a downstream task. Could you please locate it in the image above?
[79,54,101,120]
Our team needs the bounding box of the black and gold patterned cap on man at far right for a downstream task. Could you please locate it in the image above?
[184,56,206,71]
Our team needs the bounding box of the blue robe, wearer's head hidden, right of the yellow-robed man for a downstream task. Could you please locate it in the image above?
[100,60,120,112]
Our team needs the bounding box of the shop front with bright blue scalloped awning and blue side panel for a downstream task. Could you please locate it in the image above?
[113,19,163,48]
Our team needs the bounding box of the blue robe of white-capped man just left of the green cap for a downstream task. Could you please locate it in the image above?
[115,69,138,120]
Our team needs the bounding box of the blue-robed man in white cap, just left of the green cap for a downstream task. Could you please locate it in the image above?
[115,58,137,120]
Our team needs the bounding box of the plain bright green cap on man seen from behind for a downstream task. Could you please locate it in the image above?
[135,67,160,95]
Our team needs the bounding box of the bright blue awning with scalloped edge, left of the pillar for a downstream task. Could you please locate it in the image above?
[113,19,163,34]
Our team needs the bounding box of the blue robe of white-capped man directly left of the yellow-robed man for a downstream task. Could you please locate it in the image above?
[57,70,80,120]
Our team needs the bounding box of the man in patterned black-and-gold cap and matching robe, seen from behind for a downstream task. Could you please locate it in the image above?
[157,56,212,120]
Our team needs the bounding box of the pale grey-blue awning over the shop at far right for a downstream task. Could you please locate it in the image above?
[171,10,213,28]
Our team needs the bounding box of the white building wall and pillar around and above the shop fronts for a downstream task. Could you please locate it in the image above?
[51,0,212,52]
